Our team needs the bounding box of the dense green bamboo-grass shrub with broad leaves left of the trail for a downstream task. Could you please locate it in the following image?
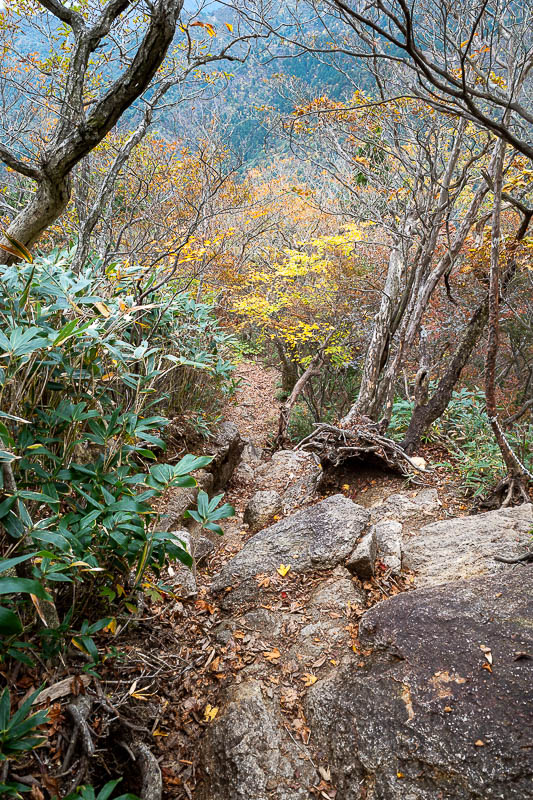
[0,252,232,665]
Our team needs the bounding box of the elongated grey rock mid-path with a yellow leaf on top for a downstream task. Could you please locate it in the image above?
[212,495,369,604]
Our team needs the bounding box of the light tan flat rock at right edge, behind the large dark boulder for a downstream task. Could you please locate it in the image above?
[403,503,533,586]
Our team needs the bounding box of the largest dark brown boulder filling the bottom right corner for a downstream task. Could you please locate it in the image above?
[305,567,533,800]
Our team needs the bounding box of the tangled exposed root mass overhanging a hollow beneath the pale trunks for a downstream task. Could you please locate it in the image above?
[297,417,425,475]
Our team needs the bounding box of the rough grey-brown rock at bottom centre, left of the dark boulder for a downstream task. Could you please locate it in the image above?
[199,681,317,800]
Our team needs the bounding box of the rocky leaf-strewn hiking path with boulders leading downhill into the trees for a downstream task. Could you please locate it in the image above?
[154,364,533,800]
